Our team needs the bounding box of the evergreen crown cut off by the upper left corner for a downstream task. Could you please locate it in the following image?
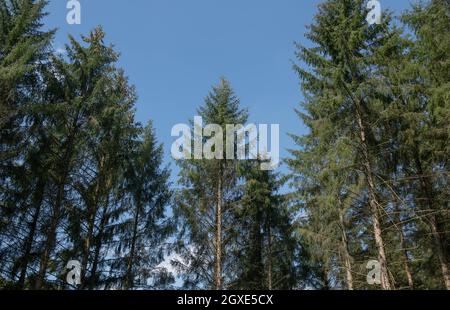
[0,0,53,128]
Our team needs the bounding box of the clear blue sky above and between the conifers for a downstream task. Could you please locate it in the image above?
[46,0,409,183]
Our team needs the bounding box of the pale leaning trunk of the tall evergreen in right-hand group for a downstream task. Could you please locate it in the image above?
[355,101,392,290]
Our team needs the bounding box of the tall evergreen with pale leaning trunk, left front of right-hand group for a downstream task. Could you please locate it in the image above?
[291,0,406,289]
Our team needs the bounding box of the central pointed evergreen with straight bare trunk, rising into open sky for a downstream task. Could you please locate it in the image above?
[175,79,247,289]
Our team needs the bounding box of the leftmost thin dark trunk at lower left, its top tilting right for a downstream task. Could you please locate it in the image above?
[17,179,45,289]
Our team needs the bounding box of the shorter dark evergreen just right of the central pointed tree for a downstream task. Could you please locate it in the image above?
[231,160,299,290]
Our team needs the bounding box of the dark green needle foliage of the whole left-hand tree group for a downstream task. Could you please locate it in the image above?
[0,0,172,289]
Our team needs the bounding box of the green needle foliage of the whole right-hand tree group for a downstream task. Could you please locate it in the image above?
[287,0,450,289]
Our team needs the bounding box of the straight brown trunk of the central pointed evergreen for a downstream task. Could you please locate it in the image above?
[214,168,222,290]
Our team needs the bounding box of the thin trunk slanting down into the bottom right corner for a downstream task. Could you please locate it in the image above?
[415,154,450,290]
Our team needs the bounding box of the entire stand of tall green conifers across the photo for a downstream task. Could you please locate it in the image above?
[0,0,450,290]
